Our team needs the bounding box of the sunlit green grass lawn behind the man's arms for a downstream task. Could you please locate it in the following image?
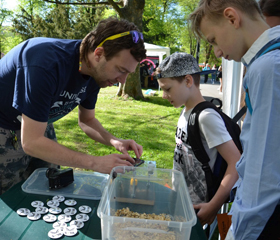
[54,86,181,169]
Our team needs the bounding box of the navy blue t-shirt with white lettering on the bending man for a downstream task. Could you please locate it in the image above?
[0,38,100,130]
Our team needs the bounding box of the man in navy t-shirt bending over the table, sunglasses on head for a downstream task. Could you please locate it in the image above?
[0,18,146,194]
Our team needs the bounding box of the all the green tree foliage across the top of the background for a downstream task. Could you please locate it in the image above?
[4,0,220,64]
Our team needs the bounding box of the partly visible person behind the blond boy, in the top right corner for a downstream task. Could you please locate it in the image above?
[259,0,280,27]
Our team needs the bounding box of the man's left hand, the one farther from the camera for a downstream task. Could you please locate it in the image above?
[111,139,143,163]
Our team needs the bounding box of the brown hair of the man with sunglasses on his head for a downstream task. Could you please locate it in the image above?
[80,17,146,62]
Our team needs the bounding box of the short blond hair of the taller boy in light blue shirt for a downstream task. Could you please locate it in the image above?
[189,0,262,38]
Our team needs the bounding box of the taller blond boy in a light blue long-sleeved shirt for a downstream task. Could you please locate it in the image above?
[190,0,280,240]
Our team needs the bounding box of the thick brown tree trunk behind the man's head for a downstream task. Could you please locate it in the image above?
[108,0,145,100]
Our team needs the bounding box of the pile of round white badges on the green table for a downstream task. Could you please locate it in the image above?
[17,195,92,239]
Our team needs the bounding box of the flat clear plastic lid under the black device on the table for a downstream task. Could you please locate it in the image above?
[21,168,109,200]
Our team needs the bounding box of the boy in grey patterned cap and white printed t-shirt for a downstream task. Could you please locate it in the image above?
[157,52,240,225]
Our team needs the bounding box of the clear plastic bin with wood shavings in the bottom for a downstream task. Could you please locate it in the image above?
[97,167,196,240]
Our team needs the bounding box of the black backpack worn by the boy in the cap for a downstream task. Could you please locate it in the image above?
[187,101,246,201]
